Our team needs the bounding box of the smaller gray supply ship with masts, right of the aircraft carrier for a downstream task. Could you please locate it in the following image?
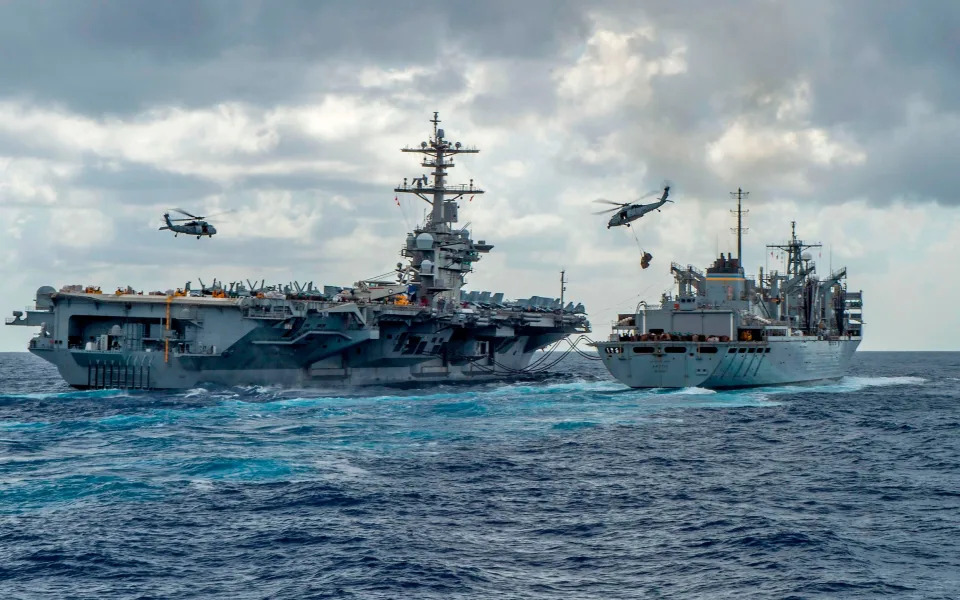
[594,190,863,389]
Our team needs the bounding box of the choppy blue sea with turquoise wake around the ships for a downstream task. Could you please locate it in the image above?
[0,353,960,599]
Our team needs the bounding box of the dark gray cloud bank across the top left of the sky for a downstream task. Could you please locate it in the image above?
[0,0,586,114]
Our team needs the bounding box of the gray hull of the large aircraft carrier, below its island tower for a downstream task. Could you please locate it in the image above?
[8,292,582,389]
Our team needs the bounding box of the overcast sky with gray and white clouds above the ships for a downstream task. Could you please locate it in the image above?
[0,0,960,351]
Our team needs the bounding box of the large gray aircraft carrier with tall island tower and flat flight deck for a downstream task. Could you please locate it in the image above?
[6,113,590,389]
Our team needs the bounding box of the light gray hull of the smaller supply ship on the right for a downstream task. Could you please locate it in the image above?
[597,336,860,389]
